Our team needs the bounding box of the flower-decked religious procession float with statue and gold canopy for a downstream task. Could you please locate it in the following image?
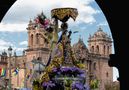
[33,8,98,90]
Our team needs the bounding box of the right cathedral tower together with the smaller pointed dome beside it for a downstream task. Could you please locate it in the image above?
[73,28,113,90]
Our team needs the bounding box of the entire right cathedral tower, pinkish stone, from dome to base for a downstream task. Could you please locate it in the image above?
[88,27,113,90]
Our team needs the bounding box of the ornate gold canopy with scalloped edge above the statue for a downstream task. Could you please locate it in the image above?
[51,8,78,22]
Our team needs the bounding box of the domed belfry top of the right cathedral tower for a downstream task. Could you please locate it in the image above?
[88,27,112,56]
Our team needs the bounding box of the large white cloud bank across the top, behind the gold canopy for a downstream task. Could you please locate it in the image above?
[0,0,100,32]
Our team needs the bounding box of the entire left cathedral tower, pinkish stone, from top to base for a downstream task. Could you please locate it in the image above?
[25,20,50,87]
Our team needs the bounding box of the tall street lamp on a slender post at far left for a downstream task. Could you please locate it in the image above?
[8,46,12,90]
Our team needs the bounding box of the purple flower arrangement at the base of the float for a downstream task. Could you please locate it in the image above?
[42,66,87,90]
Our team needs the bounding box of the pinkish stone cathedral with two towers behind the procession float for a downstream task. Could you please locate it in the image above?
[0,20,113,90]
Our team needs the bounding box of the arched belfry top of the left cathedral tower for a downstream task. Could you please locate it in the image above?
[27,20,49,49]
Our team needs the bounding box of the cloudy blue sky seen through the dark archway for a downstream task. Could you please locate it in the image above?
[0,0,118,80]
